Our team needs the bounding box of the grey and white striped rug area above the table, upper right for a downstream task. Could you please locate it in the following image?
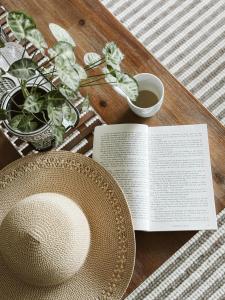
[101,0,225,124]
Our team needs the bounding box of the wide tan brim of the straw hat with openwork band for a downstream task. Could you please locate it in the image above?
[0,151,135,300]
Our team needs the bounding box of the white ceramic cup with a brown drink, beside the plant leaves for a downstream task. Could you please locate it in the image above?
[115,73,164,118]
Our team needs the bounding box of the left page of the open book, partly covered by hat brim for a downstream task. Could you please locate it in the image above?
[93,124,149,230]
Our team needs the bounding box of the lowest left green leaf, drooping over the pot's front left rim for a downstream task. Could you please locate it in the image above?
[9,114,38,132]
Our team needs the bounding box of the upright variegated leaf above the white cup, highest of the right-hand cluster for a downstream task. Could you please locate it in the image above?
[102,42,124,67]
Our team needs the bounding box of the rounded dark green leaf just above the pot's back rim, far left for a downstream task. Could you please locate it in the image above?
[8,58,38,80]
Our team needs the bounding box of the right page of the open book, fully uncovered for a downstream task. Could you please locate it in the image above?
[149,125,217,231]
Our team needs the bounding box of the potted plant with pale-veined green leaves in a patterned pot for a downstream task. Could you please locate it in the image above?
[0,11,138,150]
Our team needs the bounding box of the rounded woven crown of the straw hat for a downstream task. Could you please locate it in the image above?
[0,193,90,286]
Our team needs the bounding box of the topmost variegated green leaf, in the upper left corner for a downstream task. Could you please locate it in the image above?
[7,11,36,41]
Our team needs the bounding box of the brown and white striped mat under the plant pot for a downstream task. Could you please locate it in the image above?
[0,6,104,156]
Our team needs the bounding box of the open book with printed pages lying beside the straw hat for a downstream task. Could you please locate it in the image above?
[93,124,217,231]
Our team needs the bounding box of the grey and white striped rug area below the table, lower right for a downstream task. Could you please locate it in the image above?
[126,209,225,300]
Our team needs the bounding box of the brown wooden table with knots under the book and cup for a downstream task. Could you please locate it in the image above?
[0,0,225,294]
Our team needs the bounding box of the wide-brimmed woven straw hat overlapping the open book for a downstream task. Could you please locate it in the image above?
[0,151,135,300]
